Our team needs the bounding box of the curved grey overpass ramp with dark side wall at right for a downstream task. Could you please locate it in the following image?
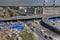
[40,14,60,35]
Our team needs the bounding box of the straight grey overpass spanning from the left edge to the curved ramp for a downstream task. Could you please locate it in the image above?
[0,15,45,21]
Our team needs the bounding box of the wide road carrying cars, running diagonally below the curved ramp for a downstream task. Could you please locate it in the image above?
[27,20,59,40]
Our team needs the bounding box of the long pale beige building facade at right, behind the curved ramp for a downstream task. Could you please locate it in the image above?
[43,7,60,14]
